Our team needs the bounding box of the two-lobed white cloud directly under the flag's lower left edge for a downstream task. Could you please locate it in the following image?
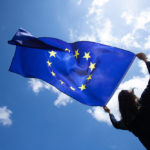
[29,79,73,107]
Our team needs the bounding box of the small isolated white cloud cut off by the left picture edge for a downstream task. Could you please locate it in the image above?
[0,106,12,126]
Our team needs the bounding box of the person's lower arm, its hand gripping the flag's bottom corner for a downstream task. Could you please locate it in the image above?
[103,106,127,130]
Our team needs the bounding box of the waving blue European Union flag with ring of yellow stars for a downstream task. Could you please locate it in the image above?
[9,29,135,106]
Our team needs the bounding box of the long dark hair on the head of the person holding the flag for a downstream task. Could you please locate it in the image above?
[118,90,140,126]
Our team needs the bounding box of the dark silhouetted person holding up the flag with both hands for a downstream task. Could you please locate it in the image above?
[103,53,150,150]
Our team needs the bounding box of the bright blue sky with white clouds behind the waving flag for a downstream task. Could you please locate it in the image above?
[0,0,150,150]
